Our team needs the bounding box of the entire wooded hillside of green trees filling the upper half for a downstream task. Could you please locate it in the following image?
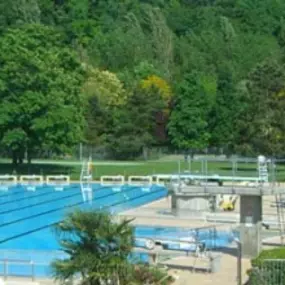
[0,0,285,159]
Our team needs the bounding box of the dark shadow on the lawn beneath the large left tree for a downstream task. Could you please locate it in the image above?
[0,163,75,175]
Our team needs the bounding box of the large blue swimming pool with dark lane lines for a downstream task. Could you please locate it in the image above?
[0,184,167,276]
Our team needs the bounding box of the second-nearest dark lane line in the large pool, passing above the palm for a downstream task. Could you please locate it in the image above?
[0,186,140,228]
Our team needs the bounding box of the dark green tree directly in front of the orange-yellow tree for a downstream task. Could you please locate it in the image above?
[105,86,166,159]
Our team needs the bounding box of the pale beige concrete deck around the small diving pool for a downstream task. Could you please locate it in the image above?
[116,196,280,285]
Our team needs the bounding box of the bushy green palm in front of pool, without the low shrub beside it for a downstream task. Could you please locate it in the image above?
[52,210,133,284]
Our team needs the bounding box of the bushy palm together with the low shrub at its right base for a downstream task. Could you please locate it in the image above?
[52,210,172,285]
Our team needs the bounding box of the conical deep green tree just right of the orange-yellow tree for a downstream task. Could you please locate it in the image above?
[168,73,210,150]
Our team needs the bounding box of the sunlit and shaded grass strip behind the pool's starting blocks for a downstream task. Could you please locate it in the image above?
[0,156,285,181]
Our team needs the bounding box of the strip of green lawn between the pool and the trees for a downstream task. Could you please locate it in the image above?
[0,156,285,181]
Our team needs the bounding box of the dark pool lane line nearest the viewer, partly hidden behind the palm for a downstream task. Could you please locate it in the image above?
[0,187,166,244]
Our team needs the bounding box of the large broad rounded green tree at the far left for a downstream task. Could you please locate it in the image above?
[0,24,85,164]
